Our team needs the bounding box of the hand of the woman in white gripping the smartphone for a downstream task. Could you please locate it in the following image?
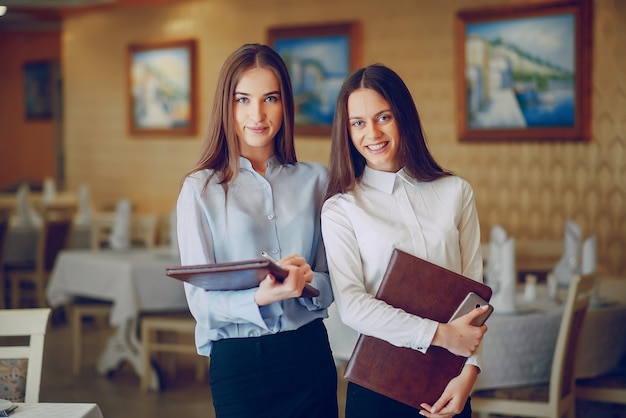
[431,305,487,357]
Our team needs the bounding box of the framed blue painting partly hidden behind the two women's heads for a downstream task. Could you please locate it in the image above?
[268,22,362,136]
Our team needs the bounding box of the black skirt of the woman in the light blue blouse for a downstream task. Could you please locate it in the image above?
[210,319,338,418]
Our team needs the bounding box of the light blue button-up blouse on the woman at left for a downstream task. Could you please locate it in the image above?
[176,157,333,355]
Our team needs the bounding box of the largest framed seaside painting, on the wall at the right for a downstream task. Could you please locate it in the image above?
[456,0,592,141]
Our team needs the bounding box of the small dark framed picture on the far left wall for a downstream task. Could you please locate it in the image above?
[23,61,55,120]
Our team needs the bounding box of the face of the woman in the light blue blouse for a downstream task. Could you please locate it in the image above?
[233,67,283,157]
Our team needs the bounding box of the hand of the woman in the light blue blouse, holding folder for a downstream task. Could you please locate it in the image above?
[254,254,313,306]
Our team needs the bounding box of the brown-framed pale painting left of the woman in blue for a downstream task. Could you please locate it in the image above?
[128,39,197,135]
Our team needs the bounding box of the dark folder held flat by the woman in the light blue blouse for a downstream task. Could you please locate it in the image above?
[165,258,320,298]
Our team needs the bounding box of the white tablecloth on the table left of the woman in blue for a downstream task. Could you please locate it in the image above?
[46,248,187,325]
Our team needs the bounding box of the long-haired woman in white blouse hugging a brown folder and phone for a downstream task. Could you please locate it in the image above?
[322,65,487,418]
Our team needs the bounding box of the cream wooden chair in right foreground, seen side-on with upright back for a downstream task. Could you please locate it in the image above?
[471,274,595,418]
